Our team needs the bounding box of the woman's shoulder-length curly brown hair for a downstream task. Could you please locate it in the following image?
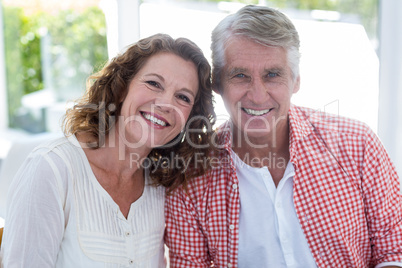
[63,34,216,192]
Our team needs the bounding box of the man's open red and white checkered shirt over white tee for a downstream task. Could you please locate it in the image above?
[165,105,402,268]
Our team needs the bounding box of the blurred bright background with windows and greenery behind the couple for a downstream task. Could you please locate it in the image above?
[0,0,402,225]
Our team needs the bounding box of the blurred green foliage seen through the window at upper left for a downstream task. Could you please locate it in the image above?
[3,6,108,132]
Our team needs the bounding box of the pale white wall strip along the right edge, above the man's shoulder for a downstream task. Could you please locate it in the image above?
[378,0,402,177]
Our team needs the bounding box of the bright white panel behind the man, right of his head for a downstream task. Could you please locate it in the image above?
[292,20,379,132]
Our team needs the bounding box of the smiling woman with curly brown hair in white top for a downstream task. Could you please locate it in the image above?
[2,34,215,268]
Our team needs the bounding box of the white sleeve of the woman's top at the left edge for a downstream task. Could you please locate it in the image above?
[2,151,64,268]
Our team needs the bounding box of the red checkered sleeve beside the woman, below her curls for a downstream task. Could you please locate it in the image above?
[165,189,211,268]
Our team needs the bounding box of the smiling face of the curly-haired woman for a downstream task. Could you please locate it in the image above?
[119,52,199,148]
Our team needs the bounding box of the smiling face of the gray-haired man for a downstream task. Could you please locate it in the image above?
[221,37,300,144]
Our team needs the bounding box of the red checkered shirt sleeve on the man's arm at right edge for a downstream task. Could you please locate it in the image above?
[362,129,402,267]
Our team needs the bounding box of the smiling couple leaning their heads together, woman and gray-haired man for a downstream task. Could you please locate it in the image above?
[2,6,402,268]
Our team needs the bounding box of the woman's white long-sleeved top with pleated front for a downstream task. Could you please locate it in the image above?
[1,137,166,268]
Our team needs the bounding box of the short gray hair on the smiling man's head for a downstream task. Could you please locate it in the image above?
[211,5,300,91]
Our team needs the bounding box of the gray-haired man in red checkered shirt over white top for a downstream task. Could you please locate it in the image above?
[165,6,402,268]
